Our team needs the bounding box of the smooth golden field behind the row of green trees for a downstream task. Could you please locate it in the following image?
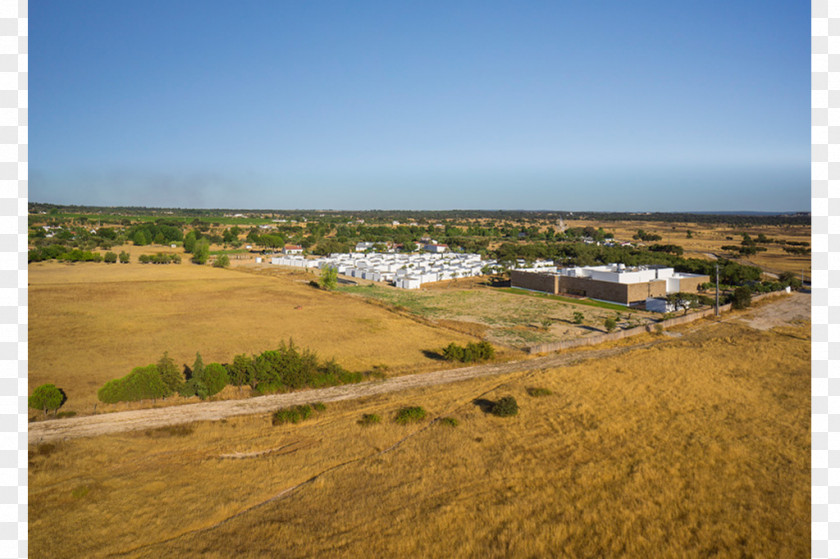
[29,262,475,415]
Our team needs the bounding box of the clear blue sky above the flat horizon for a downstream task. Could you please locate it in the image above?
[29,0,810,211]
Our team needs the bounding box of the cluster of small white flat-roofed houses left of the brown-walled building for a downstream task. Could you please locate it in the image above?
[271,253,496,289]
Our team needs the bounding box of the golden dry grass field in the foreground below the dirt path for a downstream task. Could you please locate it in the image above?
[29,298,810,558]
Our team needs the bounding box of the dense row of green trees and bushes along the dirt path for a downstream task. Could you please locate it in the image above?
[97,340,362,404]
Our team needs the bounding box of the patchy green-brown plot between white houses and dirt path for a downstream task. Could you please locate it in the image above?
[339,282,661,348]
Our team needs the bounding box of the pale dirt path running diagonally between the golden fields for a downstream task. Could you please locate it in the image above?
[29,293,811,444]
